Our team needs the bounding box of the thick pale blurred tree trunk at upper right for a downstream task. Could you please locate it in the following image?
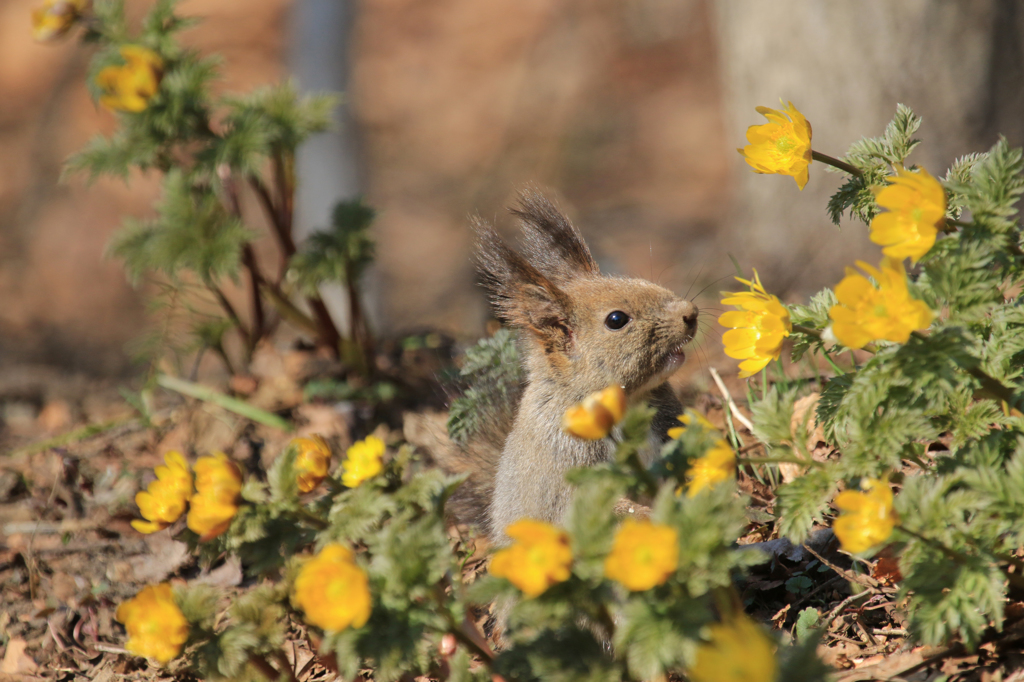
[717,0,1024,294]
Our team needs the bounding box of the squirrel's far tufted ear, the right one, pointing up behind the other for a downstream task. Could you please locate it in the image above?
[510,190,600,283]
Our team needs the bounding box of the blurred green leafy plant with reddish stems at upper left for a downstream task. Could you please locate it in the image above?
[66,0,374,375]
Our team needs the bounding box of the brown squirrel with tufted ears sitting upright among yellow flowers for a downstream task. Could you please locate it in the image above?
[407,191,697,545]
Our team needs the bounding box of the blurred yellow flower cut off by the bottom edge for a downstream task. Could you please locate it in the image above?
[689,613,778,682]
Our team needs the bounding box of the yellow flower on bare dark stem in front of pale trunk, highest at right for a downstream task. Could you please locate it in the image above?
[736,101,811,189]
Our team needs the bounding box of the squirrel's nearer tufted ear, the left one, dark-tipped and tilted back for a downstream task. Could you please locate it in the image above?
[473,218,572,353]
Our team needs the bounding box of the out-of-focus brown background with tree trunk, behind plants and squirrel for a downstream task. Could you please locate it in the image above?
[0,0,1024,382]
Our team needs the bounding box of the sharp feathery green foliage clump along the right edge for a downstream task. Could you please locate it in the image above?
[752,104,1024,647]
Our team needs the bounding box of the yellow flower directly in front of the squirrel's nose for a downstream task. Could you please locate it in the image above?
[718,270,793,379]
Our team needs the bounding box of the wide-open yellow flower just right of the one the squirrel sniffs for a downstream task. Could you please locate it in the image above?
[828,258,935,348]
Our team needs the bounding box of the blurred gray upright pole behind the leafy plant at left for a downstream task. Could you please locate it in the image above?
[289,0,377,334]
